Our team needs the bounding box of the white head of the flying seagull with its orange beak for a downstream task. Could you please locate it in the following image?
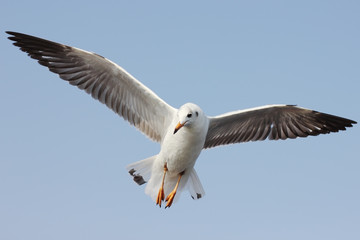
[174,103,205,134]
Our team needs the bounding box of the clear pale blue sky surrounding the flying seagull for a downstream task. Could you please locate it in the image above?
[0,0,360,240]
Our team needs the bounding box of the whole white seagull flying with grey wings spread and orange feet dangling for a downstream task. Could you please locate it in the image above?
[6,31,356,208]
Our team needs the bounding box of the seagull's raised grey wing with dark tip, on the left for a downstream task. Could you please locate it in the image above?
[7,32,175,142]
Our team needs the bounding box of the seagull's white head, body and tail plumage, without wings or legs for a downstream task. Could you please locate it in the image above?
[128,103,209,201]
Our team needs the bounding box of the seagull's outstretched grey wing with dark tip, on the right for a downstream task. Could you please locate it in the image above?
[204,105,356,148]
